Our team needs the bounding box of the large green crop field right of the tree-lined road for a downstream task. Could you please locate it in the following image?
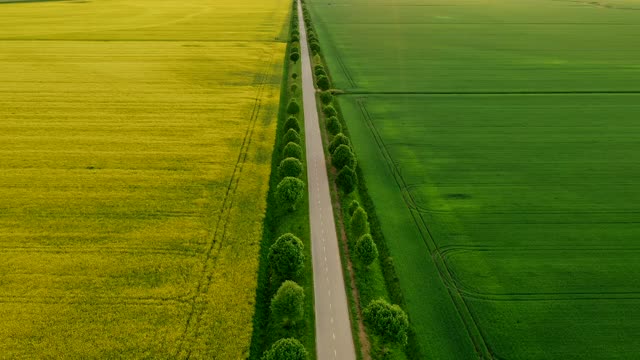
[307,0,640,359]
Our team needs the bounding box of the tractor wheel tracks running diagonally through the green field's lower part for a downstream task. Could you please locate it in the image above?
[356,98,496,359]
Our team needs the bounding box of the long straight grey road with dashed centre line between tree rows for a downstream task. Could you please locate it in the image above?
[298,0,356,360]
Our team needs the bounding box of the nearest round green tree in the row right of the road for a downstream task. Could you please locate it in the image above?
[362,299,409,346]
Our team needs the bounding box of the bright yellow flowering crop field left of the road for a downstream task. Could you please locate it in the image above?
[0,0,290,359]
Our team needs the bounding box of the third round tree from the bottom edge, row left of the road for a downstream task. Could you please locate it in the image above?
[268,233,304,280]
